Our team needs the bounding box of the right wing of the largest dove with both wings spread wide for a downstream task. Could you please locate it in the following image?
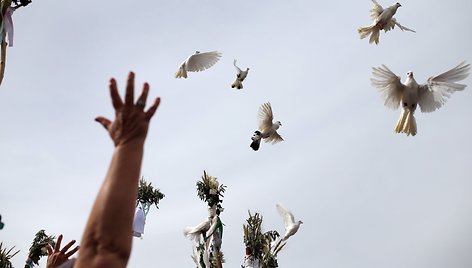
[418,62,470,113]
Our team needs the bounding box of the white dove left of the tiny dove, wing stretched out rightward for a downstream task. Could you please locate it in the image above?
[175,51,221,78]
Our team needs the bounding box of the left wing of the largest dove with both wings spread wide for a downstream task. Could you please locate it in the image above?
[370,64,405,110]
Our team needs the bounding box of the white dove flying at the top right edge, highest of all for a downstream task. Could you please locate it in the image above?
[357,0,416,44]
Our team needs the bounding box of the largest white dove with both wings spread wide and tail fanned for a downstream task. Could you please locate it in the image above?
[371,62,470,136]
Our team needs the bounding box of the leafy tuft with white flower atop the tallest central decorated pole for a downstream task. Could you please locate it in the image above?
[197,170,226,211]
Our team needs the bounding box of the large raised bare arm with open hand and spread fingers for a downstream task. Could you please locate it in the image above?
[75,72,160,268]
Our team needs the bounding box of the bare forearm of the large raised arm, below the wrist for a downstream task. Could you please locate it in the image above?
[77,141,144,267]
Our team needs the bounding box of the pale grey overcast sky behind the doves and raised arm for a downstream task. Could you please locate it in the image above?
[0,0,472,268]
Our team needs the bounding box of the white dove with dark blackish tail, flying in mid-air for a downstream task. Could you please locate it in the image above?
[250,102,284,151]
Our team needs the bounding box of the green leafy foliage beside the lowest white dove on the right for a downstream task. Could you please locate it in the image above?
[243,211,280,268]
